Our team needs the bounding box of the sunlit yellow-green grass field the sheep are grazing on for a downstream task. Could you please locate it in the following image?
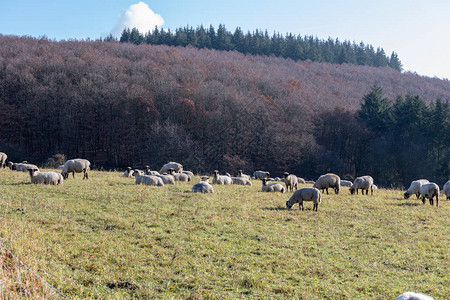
[0,169,450,299]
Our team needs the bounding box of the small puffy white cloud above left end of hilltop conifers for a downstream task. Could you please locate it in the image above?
[111,1,164,37]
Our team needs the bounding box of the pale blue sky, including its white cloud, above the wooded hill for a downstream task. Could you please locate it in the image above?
[0,0,450,79]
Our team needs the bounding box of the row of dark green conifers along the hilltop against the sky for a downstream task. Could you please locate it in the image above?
[114,24,402,72]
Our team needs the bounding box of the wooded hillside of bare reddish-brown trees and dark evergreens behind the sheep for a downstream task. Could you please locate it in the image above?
[0,36,450,186]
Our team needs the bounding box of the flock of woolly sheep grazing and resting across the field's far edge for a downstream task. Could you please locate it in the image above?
[0,152,450,211]
